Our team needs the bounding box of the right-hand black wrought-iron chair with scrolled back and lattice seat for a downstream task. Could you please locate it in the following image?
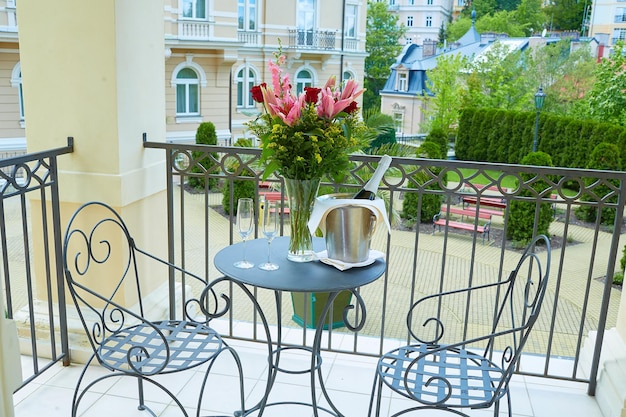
[369,235,550,417]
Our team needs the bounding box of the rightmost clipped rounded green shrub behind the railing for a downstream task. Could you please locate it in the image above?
[575,142,622,225]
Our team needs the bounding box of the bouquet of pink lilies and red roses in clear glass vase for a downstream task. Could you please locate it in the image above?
[248,52,367,262]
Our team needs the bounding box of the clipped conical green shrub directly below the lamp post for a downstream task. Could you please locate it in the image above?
[506,152,553,243]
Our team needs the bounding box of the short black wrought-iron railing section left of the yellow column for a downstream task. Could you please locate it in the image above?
[0,138,73,387]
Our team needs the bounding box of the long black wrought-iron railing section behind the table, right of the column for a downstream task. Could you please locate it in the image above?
[145,141,626,392]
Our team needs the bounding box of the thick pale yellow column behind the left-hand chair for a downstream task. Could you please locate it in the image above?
[10,0,167,368]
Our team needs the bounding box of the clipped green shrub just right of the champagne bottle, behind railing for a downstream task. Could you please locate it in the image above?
[400,145,447,223]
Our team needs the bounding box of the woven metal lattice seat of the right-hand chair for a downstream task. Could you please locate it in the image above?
[377,344,506,408]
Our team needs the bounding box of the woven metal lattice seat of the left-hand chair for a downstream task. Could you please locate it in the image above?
[98,320,224,375]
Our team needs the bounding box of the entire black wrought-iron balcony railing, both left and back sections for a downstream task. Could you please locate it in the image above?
[0,141,626,393]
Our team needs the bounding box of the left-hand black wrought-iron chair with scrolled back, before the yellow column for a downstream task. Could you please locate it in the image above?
[63,202,244,417]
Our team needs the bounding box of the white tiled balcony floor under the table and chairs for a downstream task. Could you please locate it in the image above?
[14,341,602,417]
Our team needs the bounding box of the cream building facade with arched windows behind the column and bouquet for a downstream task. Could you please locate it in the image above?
[0,0,367,157]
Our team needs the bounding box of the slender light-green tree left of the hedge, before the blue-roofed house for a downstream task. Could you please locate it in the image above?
[421,54,467,135]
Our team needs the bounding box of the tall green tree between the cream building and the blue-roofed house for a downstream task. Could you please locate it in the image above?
[363,0,406,110]
